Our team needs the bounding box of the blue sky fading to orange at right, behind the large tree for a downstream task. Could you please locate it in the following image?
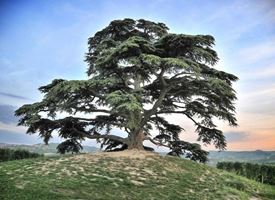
[0,0,275,151]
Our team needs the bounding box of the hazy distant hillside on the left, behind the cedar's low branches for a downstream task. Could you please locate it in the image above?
[0,143,99,154]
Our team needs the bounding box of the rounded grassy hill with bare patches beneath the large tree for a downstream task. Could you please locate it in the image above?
[0,151,275,200]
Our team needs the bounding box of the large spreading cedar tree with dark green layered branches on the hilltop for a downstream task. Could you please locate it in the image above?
[16,19,237,162]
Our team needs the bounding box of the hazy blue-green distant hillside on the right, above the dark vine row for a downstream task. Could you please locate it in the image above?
[208,150,275,166]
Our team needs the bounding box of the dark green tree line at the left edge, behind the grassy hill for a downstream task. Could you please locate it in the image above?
[0,148,42,162]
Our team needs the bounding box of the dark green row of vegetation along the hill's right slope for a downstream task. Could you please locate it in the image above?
[217,162,275,185]
